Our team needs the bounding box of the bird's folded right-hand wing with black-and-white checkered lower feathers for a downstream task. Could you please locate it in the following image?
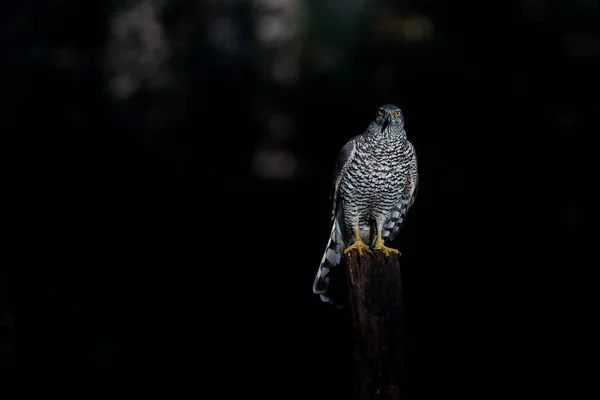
[381,144,419,243]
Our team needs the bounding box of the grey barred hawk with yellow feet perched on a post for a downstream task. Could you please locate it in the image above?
[313,104,419,305]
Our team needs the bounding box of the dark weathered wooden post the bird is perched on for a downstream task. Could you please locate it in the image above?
[346,251,403,400]
